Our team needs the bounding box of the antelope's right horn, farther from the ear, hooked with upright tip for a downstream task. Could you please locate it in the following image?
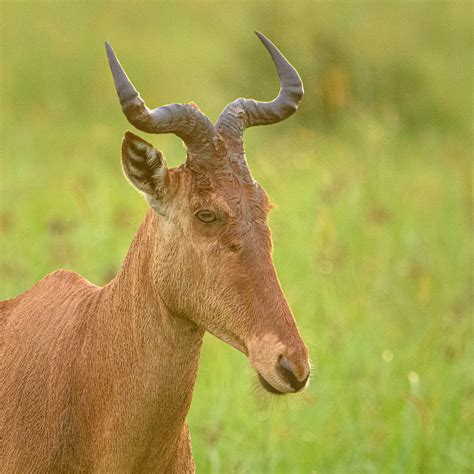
[216,31,304,137]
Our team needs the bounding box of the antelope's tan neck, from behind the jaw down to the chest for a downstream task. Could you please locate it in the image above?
[82,210,204,467]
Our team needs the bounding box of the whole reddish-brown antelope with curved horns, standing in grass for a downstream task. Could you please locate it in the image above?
[0,33,310,473]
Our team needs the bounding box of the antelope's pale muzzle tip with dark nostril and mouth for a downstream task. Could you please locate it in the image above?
[248,335,310,395]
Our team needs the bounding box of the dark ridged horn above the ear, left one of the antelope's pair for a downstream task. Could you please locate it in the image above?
[105,42,216,155]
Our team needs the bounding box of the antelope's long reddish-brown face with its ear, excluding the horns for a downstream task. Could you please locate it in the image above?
[122,133,309,393]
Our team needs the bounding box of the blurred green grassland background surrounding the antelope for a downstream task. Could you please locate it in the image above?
[0,0,474,474]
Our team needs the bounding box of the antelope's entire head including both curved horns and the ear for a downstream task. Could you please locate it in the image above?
[106,33,310,394]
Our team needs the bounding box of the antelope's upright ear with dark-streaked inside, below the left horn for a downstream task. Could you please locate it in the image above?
[122,132,168,214]
